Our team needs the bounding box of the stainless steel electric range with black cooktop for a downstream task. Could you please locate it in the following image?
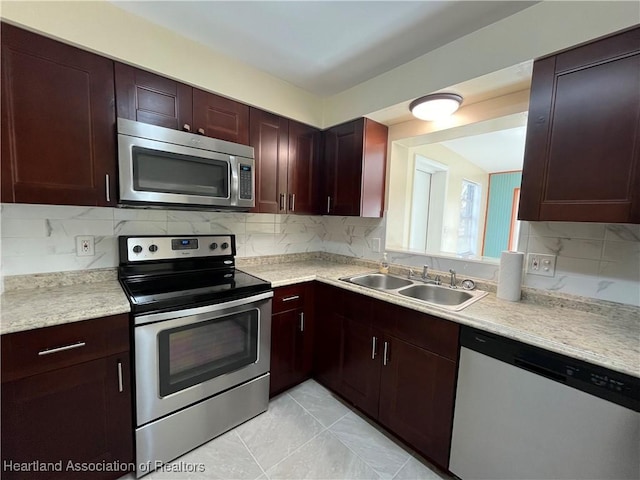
[118,235,273,477]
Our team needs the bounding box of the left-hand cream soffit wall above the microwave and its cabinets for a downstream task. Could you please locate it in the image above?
[0,1,322,126]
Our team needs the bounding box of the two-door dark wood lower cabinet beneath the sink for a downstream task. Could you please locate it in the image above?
[314,284,459,469]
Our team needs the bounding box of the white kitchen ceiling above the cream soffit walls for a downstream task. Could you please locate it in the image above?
[112,1,537,96]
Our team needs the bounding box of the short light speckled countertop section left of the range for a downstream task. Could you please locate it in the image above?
[0,279,130,334]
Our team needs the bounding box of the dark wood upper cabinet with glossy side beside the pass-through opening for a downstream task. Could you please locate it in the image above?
[321,118,388,217]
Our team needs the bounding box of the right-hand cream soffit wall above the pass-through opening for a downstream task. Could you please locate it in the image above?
[324,0,640,125]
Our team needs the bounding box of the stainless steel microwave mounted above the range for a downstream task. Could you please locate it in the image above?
[118,118,255,210]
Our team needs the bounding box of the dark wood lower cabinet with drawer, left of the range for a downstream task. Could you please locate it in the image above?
[1,315,133,479]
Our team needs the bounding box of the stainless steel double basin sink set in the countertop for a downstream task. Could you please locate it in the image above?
[341,273,487,311]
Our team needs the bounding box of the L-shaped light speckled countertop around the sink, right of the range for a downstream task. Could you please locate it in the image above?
[240,260,640,377]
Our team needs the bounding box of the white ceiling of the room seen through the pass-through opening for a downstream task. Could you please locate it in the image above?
[442,126,527,173]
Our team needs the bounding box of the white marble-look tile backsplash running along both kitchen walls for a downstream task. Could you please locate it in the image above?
[0,204,640,305]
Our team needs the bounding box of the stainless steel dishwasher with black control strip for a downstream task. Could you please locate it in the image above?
[449,327,640,480]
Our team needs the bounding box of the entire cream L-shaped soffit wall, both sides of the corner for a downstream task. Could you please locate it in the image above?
[0,1,640,127]
